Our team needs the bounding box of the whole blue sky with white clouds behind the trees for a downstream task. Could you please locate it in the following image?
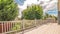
[15,0,58,16]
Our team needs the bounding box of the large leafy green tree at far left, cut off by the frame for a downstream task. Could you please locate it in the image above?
[0,0,18,21]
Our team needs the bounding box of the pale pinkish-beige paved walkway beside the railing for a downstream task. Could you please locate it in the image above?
[16,23,60,34]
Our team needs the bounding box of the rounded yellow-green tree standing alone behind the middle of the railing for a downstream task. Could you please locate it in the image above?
[22,5,43,20]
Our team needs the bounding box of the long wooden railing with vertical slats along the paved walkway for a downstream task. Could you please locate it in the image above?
[0,20,55,34]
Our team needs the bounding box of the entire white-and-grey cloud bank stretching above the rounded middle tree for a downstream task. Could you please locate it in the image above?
[18,0,58,15]
